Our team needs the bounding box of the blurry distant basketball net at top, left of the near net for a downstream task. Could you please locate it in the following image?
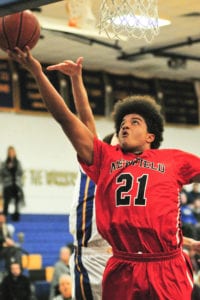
[66,0,96,29]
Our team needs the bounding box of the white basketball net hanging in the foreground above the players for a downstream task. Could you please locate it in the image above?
[98,0,159,42]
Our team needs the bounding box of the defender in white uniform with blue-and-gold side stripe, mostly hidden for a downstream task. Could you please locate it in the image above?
[47,57,111,300]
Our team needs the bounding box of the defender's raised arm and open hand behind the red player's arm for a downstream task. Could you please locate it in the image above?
[47,57,97,135]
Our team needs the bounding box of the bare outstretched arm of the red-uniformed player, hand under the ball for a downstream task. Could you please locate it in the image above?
[8,47,94,164]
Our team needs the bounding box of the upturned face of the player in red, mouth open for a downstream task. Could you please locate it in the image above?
[118,114,154,152]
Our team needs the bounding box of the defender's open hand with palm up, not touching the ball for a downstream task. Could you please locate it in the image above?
[47,57,83,77]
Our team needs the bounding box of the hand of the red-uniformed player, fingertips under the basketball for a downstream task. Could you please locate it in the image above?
[7,46,42,76]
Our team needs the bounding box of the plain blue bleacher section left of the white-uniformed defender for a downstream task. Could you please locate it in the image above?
[7,214,73,267]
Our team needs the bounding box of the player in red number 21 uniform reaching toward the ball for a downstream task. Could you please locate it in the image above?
[8,48,200,300]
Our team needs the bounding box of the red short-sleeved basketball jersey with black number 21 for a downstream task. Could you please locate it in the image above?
[81,139,200,253]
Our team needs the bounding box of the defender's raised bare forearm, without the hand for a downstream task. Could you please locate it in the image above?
[71,74,97,135]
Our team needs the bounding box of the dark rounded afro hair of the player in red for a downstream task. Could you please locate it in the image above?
[113,95,164,149]
